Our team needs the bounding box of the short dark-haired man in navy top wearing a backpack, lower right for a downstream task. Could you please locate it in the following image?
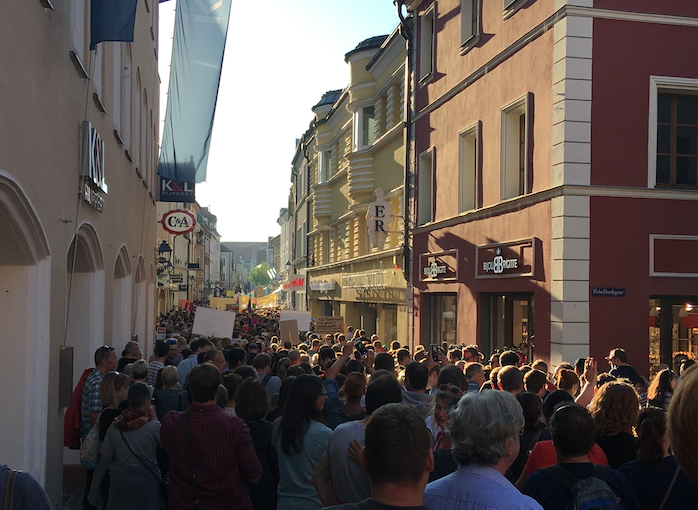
[521,403,638,510]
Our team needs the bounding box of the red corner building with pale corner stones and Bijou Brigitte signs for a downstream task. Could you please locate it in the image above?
[406,0,698,373]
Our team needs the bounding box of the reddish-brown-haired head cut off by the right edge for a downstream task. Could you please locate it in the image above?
[667,365,698,483]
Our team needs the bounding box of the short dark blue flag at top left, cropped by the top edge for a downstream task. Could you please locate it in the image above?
[90,0,138,51]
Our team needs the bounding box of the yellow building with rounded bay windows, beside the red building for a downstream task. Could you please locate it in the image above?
[302,30,407,344]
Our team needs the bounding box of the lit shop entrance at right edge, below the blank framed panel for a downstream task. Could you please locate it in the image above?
[649,296,698,371]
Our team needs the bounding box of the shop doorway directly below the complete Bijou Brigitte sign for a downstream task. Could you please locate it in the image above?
[480,293,534,360]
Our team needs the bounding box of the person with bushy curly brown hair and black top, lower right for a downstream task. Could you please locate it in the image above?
[589,381,640,469]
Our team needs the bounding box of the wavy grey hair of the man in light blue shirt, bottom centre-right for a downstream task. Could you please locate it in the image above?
[446,390,525,466]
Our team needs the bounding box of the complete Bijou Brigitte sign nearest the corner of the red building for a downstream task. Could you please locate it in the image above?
[475,238,535,278]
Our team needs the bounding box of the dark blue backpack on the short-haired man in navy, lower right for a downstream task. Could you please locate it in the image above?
[541,464,623,510]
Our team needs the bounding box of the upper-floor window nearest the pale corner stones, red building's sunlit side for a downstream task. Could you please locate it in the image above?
[501,94,531,200]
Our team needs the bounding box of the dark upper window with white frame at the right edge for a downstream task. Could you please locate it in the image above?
[656,93,698,188]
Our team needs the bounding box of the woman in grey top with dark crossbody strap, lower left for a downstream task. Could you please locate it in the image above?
[89,383,162,510]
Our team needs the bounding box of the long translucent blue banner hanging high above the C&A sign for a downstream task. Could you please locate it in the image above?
[158,0,232,182]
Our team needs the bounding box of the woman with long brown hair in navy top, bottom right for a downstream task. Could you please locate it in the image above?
[620,407,698,510]
